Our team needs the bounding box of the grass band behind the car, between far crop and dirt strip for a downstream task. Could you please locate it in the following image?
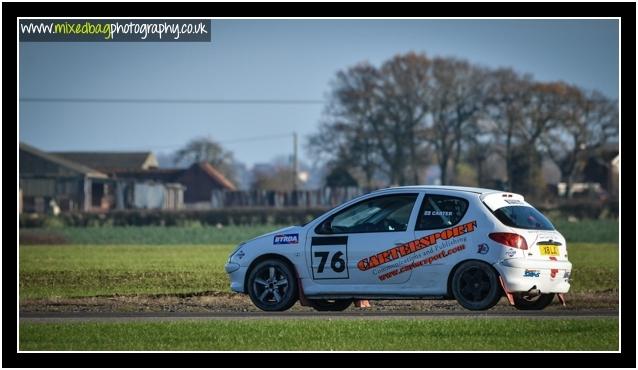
[20,243,618,299]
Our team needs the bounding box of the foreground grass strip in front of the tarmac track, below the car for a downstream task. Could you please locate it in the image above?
[20,318,618,351]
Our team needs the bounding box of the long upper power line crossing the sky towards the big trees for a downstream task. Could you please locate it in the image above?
[20,97,325,105]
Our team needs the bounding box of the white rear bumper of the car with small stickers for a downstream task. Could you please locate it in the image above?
[494,258,572,293]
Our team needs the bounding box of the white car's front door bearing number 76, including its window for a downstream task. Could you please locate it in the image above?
[306,192,420,292]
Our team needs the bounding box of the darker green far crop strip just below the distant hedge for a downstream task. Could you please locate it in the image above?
[20,219,618,245]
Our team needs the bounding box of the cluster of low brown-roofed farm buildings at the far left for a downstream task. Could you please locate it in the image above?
[19,143,236,213]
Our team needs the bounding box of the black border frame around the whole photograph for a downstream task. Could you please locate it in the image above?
[2,2,636,368]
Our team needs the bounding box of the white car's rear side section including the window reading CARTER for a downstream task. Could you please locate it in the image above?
[410,192,476,295]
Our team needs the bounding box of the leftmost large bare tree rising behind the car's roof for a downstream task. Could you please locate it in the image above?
[309,53,430,186]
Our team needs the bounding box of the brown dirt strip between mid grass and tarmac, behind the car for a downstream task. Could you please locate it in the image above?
[20,292,618,314]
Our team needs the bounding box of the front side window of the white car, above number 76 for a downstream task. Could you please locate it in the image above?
[315,194,418,234]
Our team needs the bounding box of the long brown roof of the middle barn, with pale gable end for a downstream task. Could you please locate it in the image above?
[53,152,157,172]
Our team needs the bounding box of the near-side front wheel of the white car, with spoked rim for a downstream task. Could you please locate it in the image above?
[247,259,297,311]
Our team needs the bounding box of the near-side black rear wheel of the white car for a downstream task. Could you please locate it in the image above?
[452,261,503,311]
